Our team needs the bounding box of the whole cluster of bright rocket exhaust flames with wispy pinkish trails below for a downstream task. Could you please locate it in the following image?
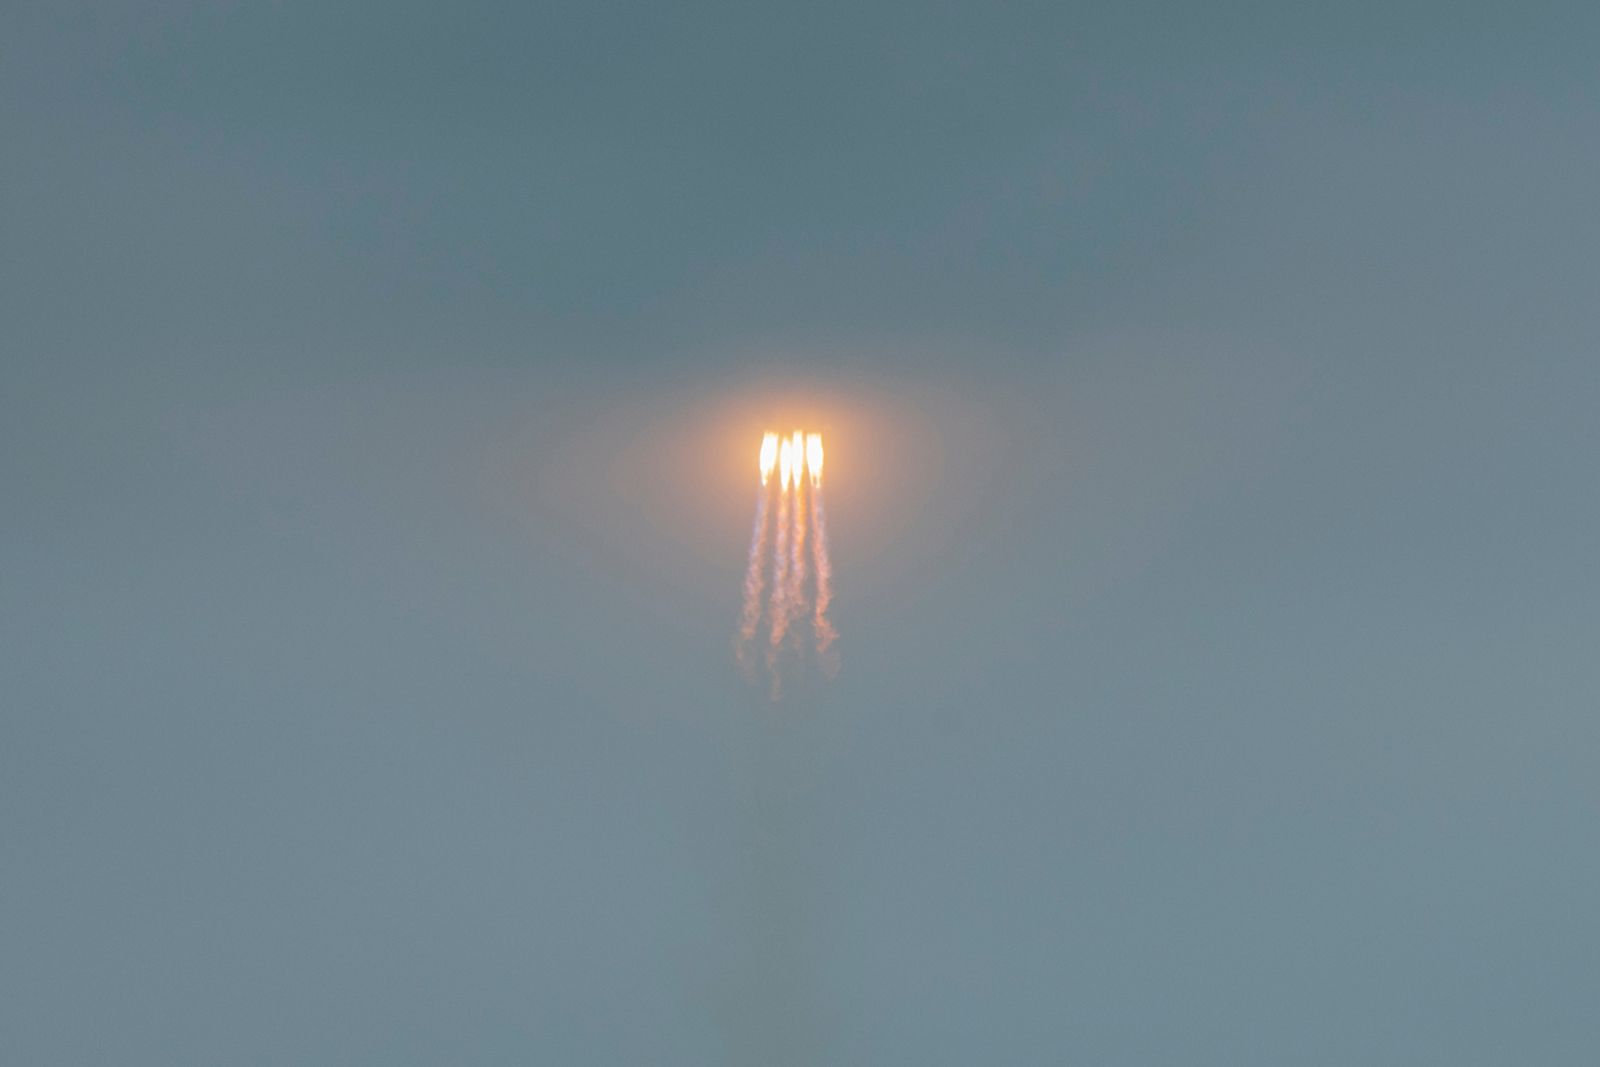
[734,430,838,701]
